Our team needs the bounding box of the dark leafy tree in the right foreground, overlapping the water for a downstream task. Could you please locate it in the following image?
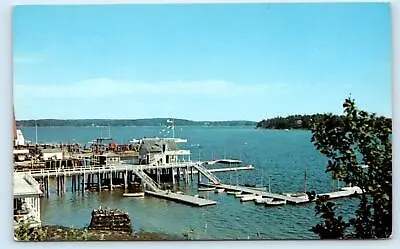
[311,98,392,239]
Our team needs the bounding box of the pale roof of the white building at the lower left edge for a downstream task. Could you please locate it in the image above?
[13,172,43,197]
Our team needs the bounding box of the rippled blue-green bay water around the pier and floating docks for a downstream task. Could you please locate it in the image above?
[23,127,357,239]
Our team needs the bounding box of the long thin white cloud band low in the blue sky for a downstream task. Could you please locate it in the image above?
[14,78,285,99]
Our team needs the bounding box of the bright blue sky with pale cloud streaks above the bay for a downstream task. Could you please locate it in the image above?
[13,3,392,121]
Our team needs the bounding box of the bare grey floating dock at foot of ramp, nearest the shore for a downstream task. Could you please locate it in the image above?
[145,191,217,207]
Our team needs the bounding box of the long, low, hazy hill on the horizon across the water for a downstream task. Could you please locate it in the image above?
[17,118,257,127]
